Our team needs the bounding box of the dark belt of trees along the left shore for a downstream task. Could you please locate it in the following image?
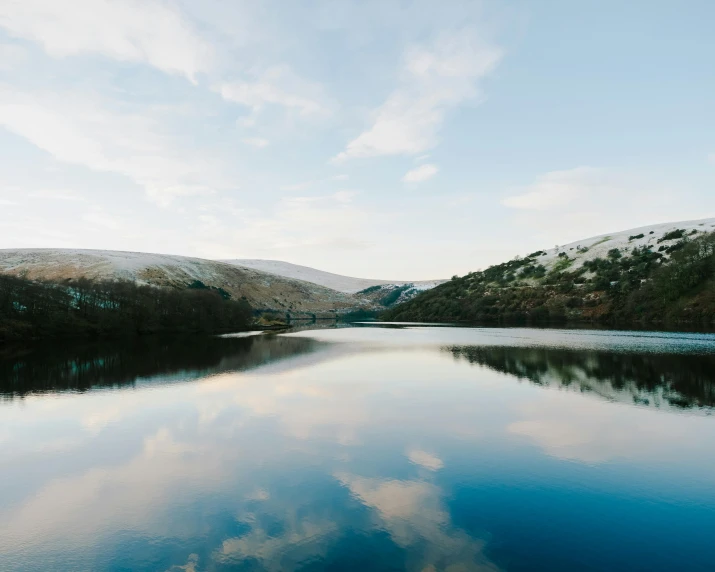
[0,275,253,340]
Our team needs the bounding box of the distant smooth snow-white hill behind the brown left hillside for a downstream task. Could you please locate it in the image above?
[221,259,446,294]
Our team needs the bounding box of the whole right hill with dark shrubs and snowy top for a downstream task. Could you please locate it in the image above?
[382,218,715,324]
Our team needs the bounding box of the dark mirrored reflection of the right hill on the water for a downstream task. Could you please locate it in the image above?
[445,346,715,408]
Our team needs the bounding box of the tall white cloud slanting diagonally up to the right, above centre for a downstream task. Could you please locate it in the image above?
[333,31,501,162]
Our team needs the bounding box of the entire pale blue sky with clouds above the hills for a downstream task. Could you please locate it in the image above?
[0,0,715,280]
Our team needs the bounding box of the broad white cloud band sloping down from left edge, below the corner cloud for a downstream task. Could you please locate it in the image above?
[0,89,227,205]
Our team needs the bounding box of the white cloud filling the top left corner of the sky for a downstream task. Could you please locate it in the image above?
[0,0,211,81]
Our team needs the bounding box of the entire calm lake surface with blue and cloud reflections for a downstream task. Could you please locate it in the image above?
[0,326,715,572]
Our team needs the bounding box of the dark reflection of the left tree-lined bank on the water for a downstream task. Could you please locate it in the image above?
[0,336,322,396]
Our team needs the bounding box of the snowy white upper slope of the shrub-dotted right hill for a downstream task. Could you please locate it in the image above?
[524,218,715,271]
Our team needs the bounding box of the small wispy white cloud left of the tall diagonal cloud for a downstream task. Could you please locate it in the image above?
[220,66,332,117]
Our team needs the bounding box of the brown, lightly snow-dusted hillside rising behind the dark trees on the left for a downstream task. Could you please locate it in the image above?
[0,249,360,317]
